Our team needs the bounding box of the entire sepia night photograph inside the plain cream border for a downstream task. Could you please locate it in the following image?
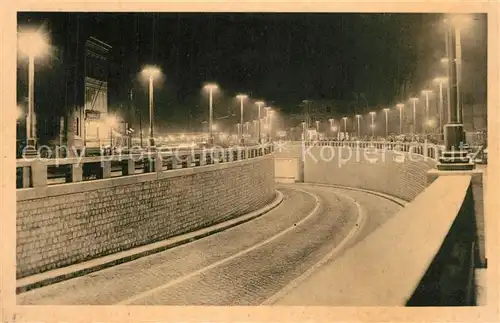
[2,1,498,320]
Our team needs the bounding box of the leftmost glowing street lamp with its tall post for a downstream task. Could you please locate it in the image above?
[18,31,49,156]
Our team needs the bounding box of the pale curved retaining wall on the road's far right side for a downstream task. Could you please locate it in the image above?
[303,146,436,201]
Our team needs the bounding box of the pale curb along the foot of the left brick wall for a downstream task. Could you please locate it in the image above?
[16,190,283,294]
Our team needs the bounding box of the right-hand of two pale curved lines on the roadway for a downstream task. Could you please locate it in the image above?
[260,190,366,305]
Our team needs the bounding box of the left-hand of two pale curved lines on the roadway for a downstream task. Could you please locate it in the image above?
[115,188,321,305]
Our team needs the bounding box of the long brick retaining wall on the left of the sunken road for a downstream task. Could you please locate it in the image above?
[16,155,275,278]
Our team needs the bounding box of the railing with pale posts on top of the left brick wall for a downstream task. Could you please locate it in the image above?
[16,144,274,189]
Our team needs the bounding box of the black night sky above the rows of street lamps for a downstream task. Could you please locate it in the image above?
[18,13,486,133]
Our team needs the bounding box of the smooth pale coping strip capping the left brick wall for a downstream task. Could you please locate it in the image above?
[16,153,274,202]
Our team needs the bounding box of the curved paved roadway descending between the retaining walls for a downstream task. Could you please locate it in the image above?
[17,184,401,305]
